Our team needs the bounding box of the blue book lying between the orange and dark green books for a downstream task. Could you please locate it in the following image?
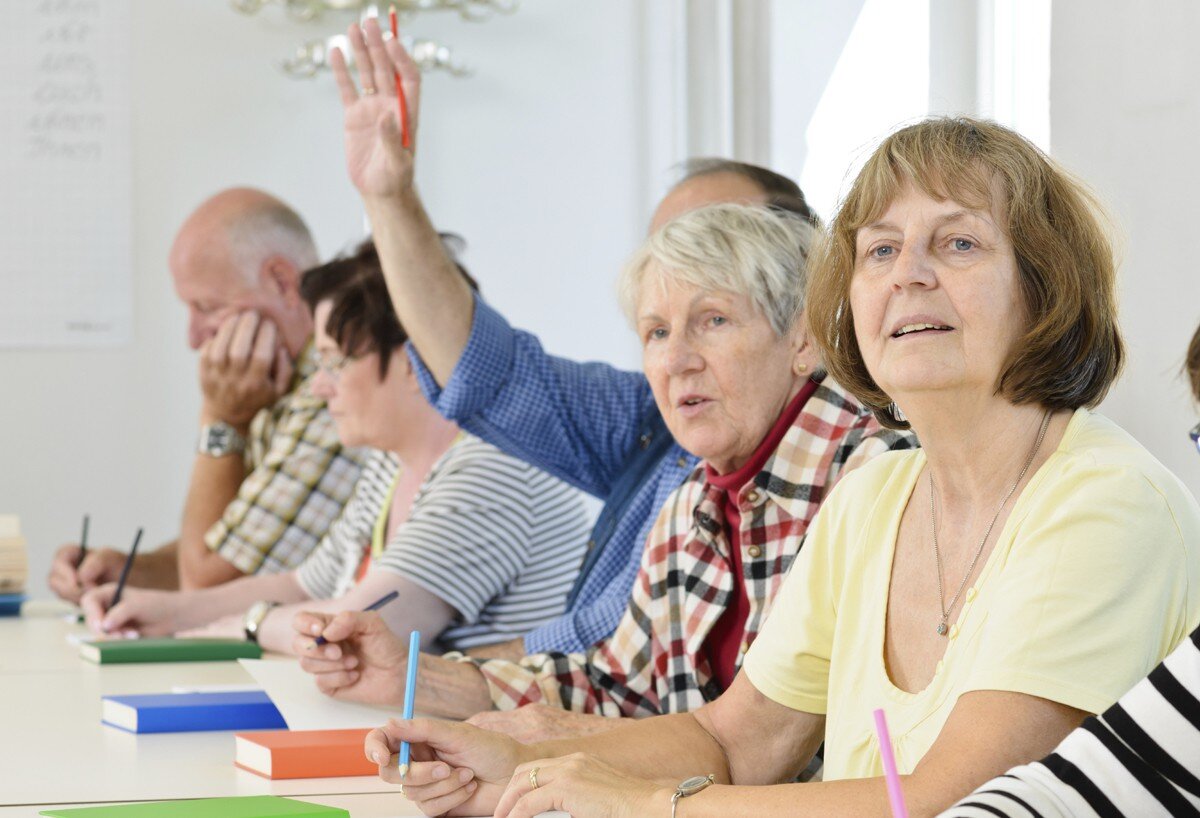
[101,690,288,733]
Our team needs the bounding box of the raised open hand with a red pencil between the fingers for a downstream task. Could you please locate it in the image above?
[329,18,421,199]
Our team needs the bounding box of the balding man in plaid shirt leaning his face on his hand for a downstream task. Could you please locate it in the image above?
[49,188,360,602]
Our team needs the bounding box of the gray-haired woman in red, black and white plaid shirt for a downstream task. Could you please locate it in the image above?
[296,205,913,727]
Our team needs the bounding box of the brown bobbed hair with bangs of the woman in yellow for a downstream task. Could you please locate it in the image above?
[808,118,1124,428]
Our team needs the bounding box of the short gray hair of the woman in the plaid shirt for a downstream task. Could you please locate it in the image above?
[617,204,817,336]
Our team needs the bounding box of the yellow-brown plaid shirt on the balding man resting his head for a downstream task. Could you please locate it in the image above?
[204,343,365,573]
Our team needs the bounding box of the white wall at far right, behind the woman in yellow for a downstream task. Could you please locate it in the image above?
[1050,0,1200,495]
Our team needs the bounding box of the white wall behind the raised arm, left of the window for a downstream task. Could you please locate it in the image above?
[0,0,659,595]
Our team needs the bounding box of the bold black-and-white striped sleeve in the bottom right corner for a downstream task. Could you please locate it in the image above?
[942,630,1200,818]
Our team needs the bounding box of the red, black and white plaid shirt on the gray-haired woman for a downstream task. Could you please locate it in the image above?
[463,378,916,716]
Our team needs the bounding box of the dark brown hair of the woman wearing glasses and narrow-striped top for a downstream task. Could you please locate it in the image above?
[300,234,479,379]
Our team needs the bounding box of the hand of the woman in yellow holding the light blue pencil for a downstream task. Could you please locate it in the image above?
[365,718,533,816]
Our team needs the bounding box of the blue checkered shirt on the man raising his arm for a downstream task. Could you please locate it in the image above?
[409,296,697,654]
